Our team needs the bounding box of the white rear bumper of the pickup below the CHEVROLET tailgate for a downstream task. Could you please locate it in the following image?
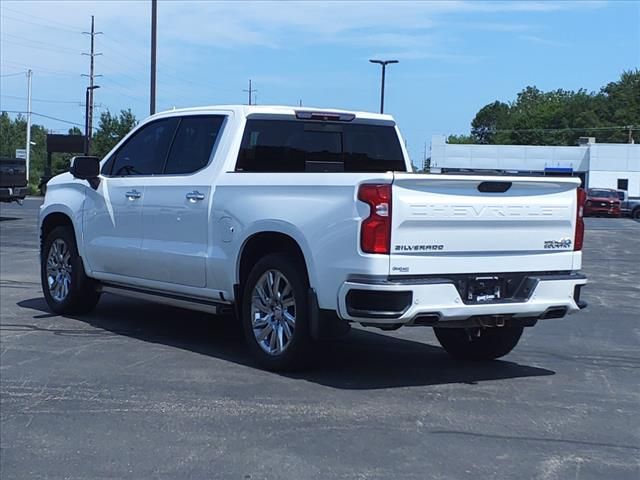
[338,274,587,325]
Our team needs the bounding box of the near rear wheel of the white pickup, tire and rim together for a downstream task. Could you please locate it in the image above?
[242,254,313,371]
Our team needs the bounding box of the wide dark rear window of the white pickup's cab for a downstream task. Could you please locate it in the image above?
[236,120,406,172]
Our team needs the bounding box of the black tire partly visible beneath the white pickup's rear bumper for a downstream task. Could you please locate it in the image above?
[433,327,523,360]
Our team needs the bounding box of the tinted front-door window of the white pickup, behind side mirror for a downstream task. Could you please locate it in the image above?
[108,117,178,176]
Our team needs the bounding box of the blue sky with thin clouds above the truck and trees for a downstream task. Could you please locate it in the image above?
[0,0,640,168]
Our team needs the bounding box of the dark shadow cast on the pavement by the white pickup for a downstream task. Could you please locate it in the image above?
[16,295,555,390]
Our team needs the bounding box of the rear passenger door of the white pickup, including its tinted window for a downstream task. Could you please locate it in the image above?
[139,115,225,287]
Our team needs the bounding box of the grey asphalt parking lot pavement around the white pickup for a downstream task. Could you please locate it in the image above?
[0,199,640,480]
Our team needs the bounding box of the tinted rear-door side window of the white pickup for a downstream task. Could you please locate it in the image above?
[164,115,224,174]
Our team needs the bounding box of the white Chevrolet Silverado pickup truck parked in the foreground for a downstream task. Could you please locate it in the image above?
[39,106,586,369]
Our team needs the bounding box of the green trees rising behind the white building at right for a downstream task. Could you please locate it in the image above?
[462,70,640,145]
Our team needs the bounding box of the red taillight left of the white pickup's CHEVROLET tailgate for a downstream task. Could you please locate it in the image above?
[358,184,391,255]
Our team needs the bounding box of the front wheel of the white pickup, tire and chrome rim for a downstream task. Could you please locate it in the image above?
[40,227,100,315]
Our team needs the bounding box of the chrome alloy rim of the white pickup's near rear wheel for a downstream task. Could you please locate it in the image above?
[251,270,296,355]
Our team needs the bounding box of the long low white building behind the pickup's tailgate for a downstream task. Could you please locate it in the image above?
[430,135,640,197]
